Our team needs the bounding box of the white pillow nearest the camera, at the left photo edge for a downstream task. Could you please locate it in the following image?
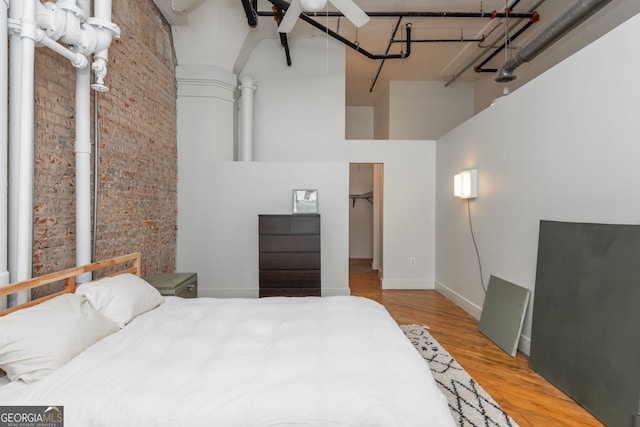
[0,294,118,383]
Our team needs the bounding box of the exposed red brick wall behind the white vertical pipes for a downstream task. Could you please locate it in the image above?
[33,0,177,290]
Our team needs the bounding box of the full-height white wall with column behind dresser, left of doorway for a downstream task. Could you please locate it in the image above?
[177,38,349,297]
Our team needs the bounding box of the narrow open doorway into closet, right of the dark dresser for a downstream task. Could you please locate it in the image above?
[349,163,384,290]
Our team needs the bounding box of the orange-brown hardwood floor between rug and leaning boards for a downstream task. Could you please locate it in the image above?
[349,262,603,427]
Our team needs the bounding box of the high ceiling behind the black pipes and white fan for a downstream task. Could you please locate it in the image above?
[154,0,640,106]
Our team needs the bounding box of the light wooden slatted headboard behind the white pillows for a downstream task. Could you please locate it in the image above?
[0,252,140,316]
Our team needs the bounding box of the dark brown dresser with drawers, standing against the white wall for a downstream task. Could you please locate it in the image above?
[258,214,321,297]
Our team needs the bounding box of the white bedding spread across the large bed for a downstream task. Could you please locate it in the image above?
[0,297,455,427]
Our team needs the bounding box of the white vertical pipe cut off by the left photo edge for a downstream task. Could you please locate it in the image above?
[0,0,11,310]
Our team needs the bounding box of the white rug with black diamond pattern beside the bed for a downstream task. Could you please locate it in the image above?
[400,325,518,427]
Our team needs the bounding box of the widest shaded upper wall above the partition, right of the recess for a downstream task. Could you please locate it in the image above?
[389,81,473,139]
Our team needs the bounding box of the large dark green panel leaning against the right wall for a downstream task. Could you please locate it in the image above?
[530,221,640,427]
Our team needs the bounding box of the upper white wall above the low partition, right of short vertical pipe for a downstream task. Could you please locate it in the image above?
[241,37,345,162]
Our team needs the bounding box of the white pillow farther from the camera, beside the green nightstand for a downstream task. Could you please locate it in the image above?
[76,273,164,328]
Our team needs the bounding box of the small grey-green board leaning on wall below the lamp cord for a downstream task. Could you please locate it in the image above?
[478,276,531,356]
